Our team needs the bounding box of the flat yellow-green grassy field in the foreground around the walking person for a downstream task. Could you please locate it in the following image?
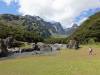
[0,45,100,75]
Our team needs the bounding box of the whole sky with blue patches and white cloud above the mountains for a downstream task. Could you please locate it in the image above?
[0,0,100,27]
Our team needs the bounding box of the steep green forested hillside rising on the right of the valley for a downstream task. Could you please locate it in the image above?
[70,12,100,43]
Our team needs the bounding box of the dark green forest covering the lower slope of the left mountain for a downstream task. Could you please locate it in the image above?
[0,22,43,42]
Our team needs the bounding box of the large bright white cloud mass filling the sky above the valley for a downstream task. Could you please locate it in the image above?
[1,0,100,27]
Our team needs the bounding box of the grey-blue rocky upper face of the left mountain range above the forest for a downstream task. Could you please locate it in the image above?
[0,14,65,37]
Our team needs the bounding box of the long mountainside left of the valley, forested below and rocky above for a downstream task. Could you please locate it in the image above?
[0,14,65,40]
